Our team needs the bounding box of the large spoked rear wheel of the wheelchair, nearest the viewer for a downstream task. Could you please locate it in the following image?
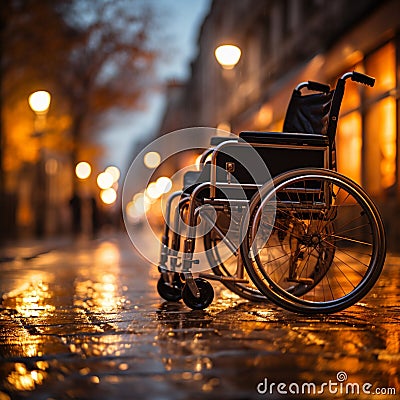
[241,169,386,314]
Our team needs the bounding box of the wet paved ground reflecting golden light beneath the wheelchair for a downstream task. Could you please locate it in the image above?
[0,237,400,400]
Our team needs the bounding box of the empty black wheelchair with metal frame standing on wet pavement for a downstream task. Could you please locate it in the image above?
[157,71,386,314]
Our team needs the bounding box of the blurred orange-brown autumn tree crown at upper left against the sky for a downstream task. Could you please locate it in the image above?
[0,0,157,238]
